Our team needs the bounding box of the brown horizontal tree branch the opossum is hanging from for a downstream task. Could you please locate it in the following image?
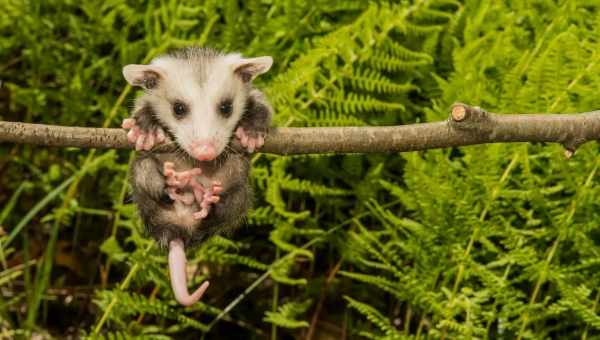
[0,103,600,157]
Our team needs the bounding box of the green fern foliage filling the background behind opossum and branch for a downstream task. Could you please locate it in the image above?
[0,0,600,339]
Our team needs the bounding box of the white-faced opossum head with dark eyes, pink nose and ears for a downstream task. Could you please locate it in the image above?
[123,48,273,161]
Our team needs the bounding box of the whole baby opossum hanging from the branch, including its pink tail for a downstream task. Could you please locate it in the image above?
[123,47,273,305]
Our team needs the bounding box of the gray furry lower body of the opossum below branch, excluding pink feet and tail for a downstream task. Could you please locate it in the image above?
[130,152,253,248]
